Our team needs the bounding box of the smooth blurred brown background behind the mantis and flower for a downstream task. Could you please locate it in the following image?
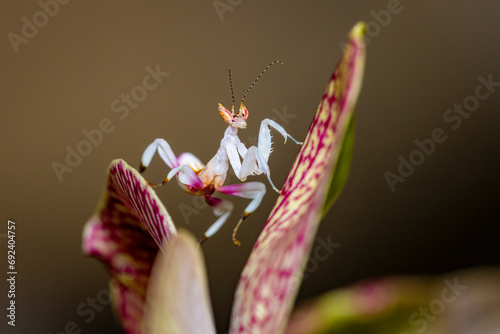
[0,0,500,334]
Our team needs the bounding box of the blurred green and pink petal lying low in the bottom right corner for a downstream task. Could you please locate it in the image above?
[285,268,500,334]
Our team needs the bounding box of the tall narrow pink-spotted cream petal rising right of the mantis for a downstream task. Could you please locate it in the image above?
[230,22,365,334]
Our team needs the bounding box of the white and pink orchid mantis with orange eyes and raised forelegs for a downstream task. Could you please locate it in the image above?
[140,61,302,245]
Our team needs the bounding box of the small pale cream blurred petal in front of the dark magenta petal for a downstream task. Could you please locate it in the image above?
[144,231,216,334]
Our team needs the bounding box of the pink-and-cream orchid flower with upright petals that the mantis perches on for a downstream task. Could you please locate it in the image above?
[83,22,365,334]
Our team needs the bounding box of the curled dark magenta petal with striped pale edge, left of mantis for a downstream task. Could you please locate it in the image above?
[83,160,177,333]
